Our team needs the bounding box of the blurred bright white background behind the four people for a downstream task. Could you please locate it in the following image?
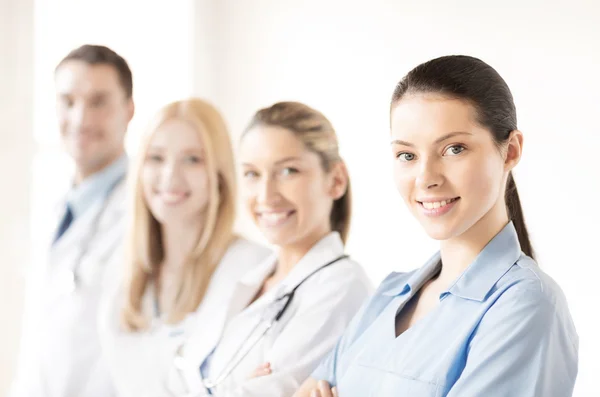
[0,0,600,397]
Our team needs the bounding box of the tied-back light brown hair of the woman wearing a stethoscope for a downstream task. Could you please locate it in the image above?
[246,102,352,243]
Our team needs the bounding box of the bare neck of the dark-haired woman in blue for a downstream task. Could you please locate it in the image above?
[438,200,509,285]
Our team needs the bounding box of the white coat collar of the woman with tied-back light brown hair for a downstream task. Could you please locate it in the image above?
[240,232,344,292]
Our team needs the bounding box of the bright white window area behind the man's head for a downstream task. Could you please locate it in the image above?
[32,0,194,260]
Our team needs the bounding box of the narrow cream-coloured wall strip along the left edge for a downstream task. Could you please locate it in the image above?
[0,0,33,395]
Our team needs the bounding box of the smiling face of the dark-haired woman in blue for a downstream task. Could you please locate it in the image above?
[391,94,514,240]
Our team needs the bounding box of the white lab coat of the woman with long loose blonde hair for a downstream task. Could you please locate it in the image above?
[100,239,271,397]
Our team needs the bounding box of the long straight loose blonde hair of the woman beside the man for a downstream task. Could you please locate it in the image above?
[121,99,236,331]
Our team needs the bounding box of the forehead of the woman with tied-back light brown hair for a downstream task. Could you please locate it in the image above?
[240,126,316,162]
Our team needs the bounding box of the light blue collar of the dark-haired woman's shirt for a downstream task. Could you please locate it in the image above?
[381,222,521,302]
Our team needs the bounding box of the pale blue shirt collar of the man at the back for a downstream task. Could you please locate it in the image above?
[67,155,128,217]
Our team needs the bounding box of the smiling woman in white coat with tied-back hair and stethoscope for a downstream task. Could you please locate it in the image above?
[164,102,371,397]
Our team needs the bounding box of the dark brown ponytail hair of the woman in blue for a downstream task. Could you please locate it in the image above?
[391,55,534,258]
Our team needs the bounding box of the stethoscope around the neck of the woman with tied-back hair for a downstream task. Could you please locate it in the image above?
[166,255,348,396]
